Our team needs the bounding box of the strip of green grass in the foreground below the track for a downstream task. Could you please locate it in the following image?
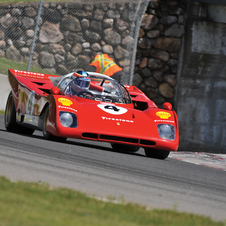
[0,177,225,226]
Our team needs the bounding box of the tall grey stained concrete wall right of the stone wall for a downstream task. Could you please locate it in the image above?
[177,1,226,153]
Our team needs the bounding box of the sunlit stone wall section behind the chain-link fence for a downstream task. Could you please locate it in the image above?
[0,0,146,84]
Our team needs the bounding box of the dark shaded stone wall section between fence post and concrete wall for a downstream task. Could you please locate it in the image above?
[133,0,187,106]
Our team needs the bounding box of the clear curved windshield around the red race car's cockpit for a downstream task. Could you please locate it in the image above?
[58,74,131,104]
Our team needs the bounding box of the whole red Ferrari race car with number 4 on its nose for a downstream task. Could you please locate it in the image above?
[5,69,179,159]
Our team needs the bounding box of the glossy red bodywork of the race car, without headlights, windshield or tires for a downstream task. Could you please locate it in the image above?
[8,69,179,151]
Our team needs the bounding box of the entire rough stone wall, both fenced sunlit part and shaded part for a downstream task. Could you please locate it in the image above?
[0,0,187,106]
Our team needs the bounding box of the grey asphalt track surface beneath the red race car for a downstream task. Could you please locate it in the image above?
[0,115,226,221]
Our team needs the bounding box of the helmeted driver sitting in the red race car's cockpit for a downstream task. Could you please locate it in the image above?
[71,71,91,95]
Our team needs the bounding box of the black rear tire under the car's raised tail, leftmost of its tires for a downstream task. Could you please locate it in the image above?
[4,91,35,135]
